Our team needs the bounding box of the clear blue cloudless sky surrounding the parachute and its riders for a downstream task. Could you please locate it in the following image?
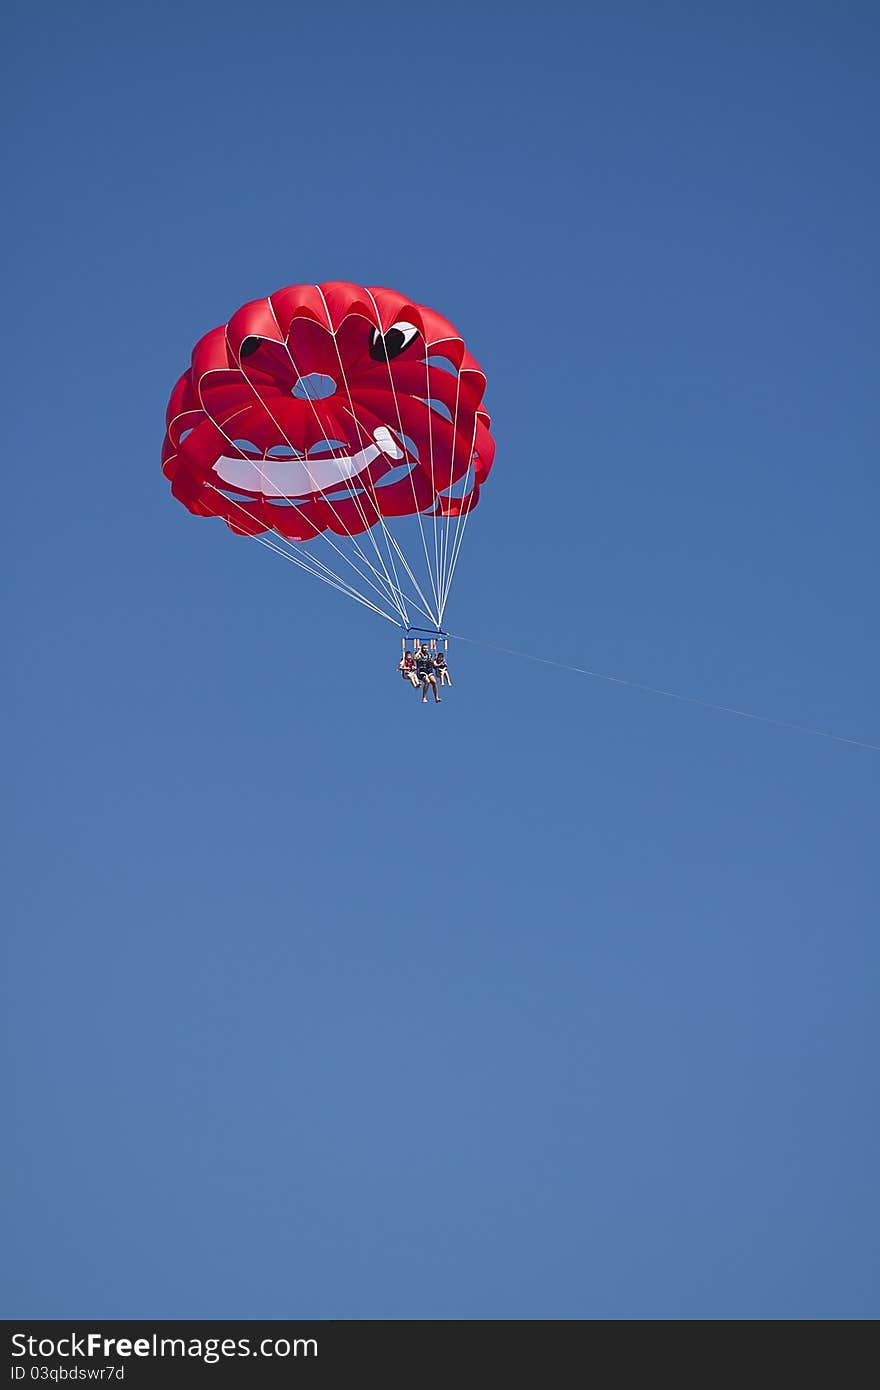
[1,0,880,1318]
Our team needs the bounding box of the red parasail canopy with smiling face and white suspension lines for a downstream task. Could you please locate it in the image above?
[163,281,495,626]
